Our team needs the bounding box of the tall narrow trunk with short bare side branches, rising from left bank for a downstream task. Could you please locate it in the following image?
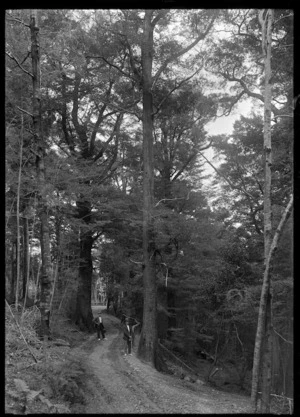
[30,10,51,337]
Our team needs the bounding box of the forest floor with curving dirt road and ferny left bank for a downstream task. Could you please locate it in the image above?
[5,307,254,414]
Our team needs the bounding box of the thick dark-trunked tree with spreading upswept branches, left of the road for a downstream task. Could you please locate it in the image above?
[38,12,131,330]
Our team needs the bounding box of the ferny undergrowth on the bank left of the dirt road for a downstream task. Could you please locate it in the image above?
[5,306,85,414]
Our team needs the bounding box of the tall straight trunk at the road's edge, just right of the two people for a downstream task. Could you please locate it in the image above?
[138,10,157,367]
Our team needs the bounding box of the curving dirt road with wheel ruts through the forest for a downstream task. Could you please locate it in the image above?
[73,308,250,414]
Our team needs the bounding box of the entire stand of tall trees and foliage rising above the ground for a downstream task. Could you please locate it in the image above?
[5,9,295,412]
